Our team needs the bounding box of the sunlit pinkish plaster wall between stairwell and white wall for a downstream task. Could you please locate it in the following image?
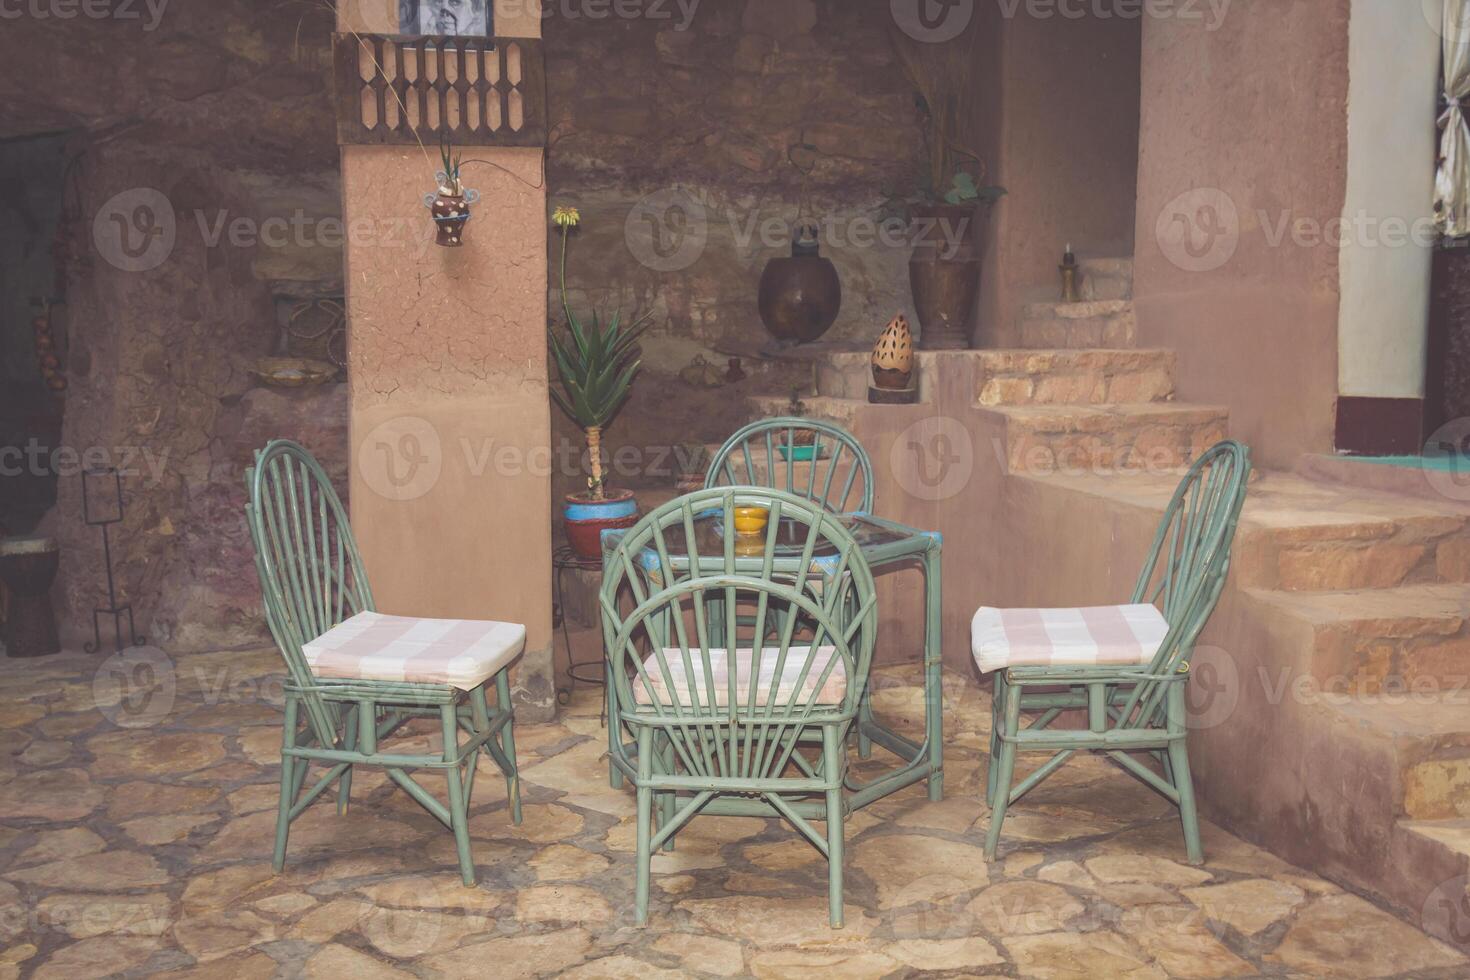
[1133,0,1348,467]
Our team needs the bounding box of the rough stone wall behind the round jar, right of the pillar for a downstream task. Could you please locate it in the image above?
[544,0,926,502]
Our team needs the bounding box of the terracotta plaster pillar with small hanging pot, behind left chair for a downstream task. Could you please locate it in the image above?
[340,1,554,720]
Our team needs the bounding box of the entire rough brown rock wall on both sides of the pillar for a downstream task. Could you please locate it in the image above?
[0,0,926,651]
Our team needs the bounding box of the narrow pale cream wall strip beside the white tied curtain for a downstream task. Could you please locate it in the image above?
[1338,0,1441,398]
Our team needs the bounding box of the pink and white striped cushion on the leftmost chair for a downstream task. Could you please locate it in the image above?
[301,613,526,691]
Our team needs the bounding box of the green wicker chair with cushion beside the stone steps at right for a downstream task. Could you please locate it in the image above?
[972,441,1251,864]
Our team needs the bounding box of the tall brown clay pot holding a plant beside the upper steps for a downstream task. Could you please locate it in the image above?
[908,204,982,351]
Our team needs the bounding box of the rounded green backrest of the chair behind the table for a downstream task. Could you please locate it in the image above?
[704,419,873,514]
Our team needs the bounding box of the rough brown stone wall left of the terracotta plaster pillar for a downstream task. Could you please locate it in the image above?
[0,0,345,651]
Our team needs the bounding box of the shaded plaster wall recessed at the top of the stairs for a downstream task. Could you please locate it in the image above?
[973,4,1141,347]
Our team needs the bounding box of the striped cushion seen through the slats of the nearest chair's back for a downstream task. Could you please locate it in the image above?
[634,646,847,707]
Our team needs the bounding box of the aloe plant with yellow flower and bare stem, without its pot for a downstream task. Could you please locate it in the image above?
[548,207,651,501]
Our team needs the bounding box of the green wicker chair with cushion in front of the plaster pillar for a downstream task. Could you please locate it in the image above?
[245,439,525,884]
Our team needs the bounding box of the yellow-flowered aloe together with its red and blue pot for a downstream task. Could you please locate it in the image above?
[548,207,648,558]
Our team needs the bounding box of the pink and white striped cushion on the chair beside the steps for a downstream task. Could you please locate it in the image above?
[970,605,1169,671]
